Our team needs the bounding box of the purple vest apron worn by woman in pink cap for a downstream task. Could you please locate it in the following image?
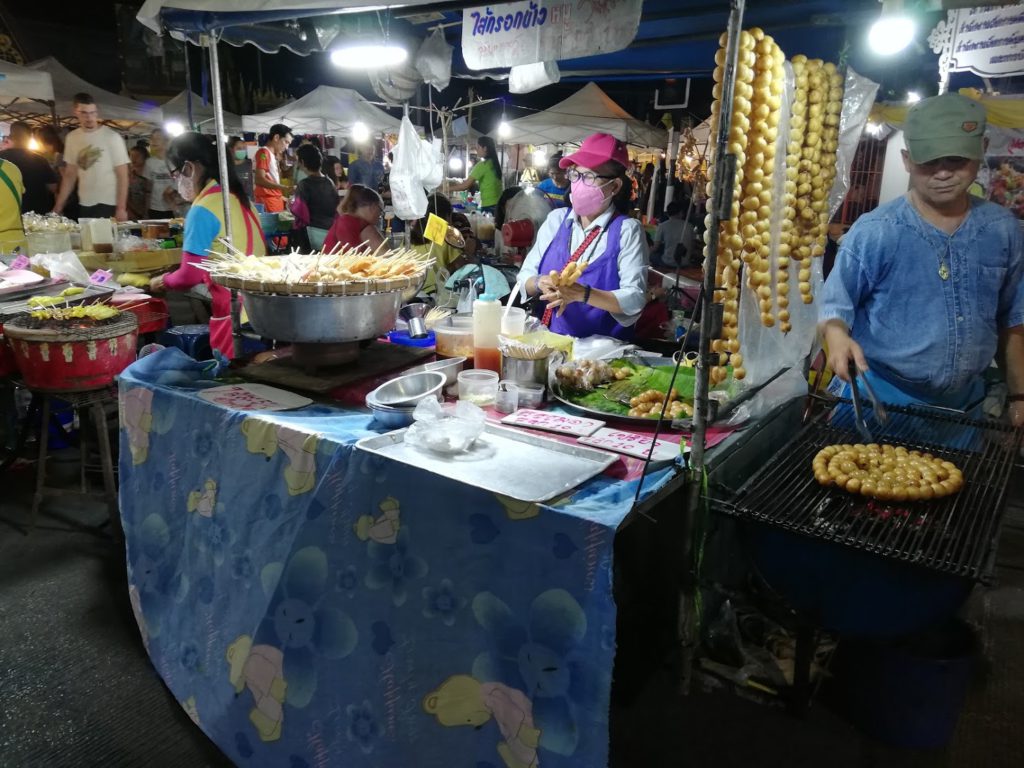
[538,209,633,341]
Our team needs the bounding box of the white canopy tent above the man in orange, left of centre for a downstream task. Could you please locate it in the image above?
[242,85,401,136]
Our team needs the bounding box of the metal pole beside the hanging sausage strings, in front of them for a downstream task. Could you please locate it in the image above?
[679,0,746,693]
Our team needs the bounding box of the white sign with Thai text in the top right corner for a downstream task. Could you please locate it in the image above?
[948,5,1024,77]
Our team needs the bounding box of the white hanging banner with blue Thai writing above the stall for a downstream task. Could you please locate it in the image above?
[462,0,643,70]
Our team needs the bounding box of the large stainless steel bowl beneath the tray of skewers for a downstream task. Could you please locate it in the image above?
[242,291,402,344]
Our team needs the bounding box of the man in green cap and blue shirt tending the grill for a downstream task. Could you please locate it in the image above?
[818,93,1024,426]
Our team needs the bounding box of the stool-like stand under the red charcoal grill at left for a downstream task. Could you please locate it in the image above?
[29,389,123,541]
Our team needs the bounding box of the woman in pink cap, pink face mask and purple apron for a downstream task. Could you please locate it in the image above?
[519,133,647,339]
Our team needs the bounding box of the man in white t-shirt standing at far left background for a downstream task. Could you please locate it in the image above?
[53,93,129,221]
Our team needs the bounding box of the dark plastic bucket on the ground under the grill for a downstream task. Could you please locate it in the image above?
[836,620,978,749]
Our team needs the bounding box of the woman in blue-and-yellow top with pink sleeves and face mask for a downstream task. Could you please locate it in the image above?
[150,133,266,357]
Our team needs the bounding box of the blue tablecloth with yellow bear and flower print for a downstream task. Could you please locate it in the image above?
[120,350,670,768]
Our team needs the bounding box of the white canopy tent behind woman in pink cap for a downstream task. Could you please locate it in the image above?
[502,83,669,150]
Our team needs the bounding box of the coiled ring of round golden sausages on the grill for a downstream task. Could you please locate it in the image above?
[811,442,964,502]
